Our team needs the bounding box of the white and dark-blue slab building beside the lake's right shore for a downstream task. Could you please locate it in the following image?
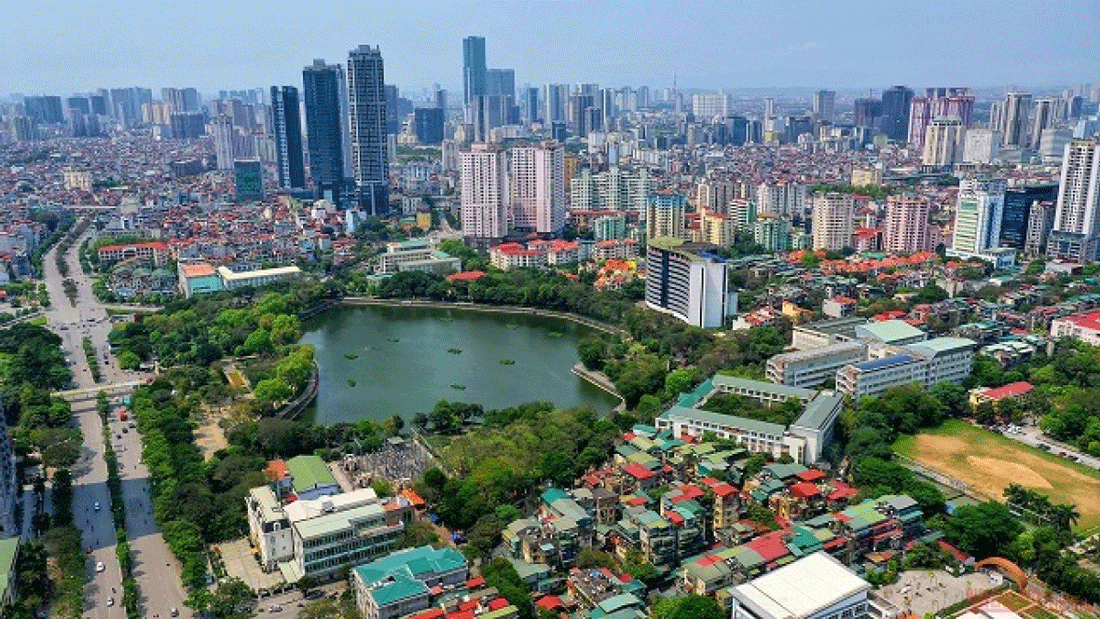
[646,237,737,328]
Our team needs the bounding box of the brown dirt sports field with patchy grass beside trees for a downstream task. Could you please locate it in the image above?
[894,421,1100,530]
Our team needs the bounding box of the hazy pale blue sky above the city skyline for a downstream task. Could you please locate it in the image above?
[0,0,1100,100]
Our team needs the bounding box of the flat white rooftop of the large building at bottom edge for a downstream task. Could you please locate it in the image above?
[733,552,870,619]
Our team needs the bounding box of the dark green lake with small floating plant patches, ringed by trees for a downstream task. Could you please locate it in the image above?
[301,306,618,423]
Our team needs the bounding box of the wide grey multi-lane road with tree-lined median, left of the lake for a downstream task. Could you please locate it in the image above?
[43,226,190,619]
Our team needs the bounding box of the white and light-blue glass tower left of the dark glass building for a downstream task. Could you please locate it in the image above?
[952,178,1004,256]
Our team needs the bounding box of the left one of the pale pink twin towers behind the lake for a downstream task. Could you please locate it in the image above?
[460,143,508,244]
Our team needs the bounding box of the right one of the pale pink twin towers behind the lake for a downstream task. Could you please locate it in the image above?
[509,142,565,235]
